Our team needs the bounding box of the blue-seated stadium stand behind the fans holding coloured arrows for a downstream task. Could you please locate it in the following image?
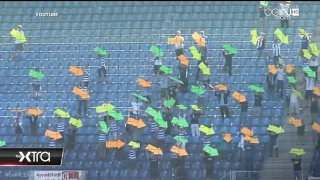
[0,1,320,180]
